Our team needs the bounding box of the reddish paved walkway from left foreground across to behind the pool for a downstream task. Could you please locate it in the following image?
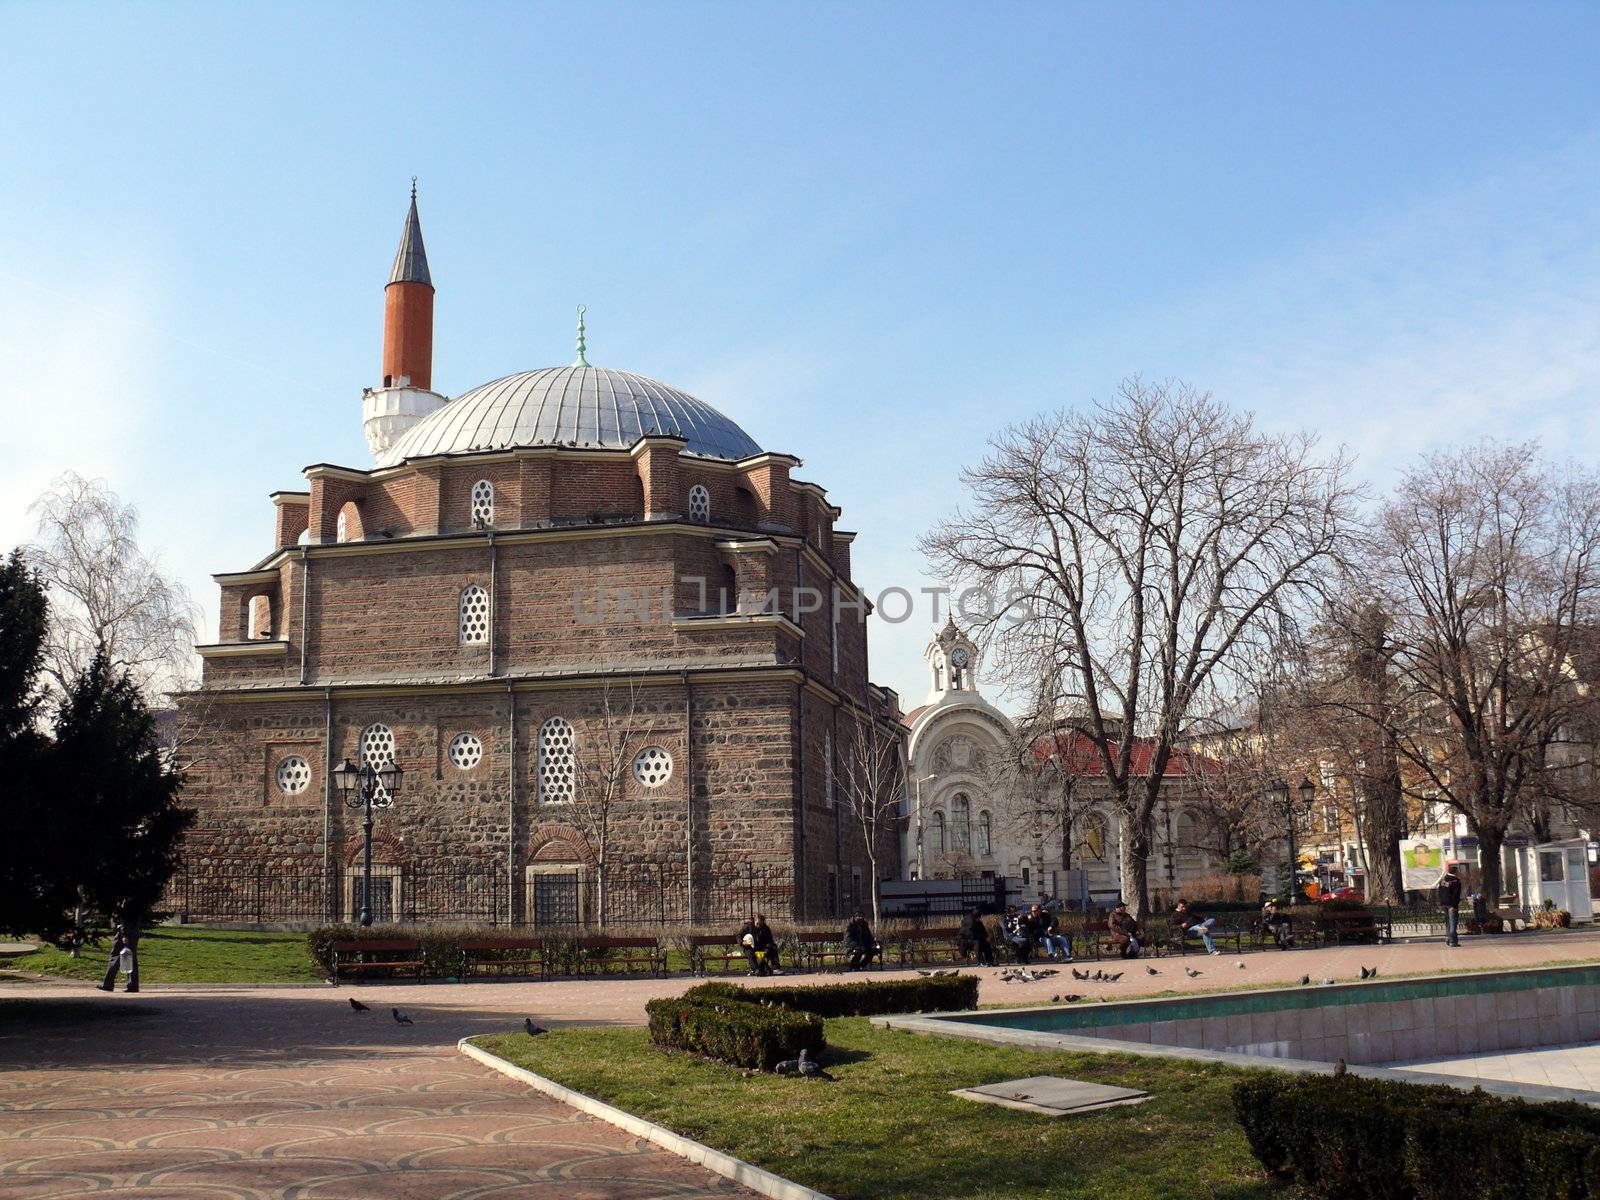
[0,931,1600,1200]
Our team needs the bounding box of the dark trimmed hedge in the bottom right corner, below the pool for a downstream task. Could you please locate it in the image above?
[1234,1075,1600,1200]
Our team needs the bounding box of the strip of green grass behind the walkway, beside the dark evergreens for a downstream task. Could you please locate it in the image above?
[5,925,323,987]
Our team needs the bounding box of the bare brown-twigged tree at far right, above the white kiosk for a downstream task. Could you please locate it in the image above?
[1365,443,1600,902]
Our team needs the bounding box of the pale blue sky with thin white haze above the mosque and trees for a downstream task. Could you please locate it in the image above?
[0,0,1600,704]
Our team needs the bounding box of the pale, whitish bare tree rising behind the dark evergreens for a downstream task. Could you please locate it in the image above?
[27,472,195,698]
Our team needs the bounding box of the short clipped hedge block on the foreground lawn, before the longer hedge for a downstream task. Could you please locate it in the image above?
[645,989,826,1070]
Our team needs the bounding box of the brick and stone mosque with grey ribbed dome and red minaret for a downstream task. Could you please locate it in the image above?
[179,189,904,925]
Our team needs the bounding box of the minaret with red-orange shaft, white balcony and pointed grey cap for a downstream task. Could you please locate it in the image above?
[362,178,445,458]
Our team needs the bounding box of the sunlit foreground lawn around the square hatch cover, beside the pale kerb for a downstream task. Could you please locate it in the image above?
[475,1018,1286,1200]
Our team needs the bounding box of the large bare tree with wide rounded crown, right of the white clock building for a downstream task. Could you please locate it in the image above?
[923,379,1354,914]
